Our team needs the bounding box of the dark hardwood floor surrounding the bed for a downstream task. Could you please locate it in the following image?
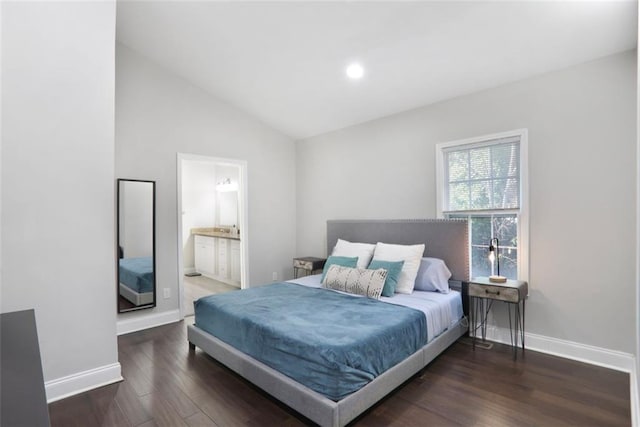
[49,322,631,427]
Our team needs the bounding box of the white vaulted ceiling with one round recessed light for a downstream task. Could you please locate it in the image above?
[117,1,637,139]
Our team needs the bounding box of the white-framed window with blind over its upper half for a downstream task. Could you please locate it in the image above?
[436,129,529,279]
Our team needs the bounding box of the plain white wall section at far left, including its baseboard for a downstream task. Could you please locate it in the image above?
[1,1,120,399]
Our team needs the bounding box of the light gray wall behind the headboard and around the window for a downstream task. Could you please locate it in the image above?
[296,51,637,354]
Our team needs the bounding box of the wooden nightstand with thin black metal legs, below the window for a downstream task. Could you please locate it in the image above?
[469,277,529,360]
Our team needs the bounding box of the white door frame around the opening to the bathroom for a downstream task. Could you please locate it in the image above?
[176,153,249,319]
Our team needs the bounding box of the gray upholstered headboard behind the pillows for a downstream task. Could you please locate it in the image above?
[327,219,469,282]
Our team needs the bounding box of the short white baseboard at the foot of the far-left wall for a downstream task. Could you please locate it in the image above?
[44,363,122,403]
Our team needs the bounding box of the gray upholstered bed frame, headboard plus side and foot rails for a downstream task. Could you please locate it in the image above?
[187,220,469,427]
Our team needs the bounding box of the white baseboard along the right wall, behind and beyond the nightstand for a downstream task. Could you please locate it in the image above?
[487,326,636,373]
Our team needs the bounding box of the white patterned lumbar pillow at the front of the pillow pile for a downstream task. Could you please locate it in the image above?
[322,264,387,299]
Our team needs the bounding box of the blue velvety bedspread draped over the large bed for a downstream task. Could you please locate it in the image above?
[194,283,427,401]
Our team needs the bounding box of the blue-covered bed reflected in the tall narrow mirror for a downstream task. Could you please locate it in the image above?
[118,257,155,305]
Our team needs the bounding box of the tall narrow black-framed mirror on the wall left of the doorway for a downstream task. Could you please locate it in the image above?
[117,179,156,313]
